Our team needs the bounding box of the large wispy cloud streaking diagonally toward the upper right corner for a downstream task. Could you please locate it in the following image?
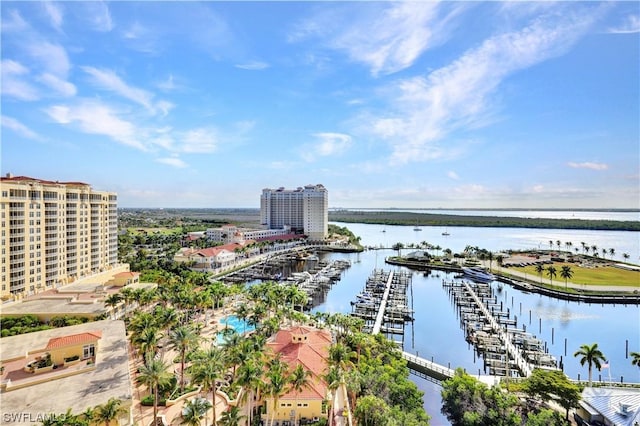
[363,7,596,164]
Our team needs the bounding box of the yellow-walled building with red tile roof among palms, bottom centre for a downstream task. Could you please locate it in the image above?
[263,326,332,424]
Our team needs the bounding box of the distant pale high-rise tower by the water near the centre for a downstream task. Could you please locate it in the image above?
[260,184,329,240]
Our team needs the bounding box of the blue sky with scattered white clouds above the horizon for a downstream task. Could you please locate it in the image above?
[0,1,640,208]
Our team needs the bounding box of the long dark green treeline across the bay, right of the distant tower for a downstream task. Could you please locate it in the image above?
[329,210,640,231]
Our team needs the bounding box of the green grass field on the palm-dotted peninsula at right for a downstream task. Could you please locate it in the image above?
[510,262,640,288]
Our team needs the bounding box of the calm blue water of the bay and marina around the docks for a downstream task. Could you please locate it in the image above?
[308,224,640,425]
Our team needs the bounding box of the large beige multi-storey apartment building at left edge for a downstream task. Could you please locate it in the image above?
[0,174,118,299]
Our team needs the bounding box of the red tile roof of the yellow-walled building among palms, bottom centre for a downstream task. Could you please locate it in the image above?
[267,327,332,399]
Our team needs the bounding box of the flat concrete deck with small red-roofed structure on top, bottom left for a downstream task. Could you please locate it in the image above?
[0,320,132,425]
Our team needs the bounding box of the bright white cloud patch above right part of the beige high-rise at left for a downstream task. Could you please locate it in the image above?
[45,101,147,151]
